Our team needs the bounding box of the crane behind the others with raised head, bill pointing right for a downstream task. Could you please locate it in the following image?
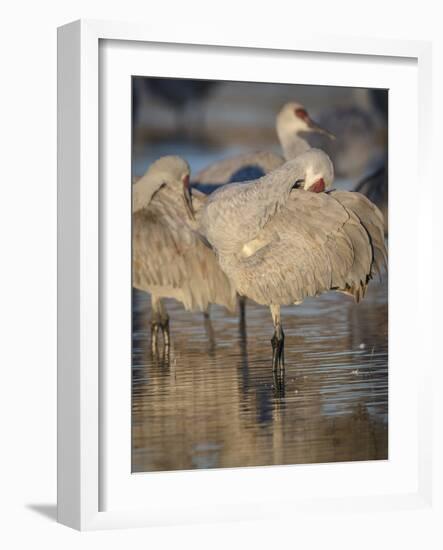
[193,101,334,193]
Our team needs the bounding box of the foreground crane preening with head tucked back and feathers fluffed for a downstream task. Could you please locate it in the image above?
[188,149,386,370]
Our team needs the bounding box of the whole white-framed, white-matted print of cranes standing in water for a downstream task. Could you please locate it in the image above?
[58,21,431,529]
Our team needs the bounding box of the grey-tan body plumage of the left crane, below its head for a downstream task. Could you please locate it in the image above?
[133,178,236,311]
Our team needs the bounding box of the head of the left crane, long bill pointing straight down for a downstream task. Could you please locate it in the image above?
[146,155,194,219]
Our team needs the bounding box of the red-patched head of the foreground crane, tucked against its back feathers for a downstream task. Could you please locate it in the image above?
[285,149,334,193]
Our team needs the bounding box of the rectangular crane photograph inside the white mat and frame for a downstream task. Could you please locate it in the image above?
[131,76,389,473]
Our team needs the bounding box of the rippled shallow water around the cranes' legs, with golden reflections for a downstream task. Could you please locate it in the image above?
[132,281,388,472]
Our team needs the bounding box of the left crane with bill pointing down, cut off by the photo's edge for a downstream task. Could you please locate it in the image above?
[132,156,236,353]
